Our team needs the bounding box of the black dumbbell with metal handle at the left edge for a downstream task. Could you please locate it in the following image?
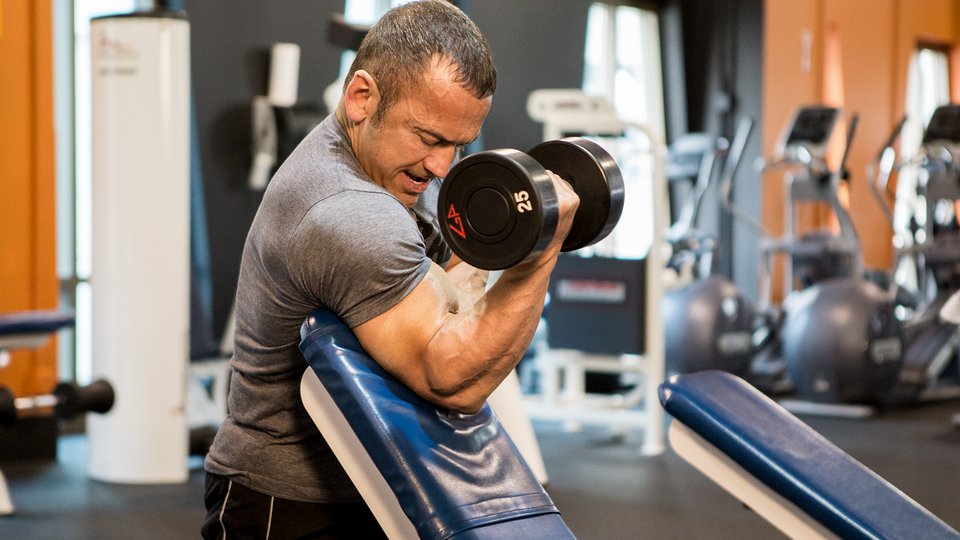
[0,380,114,427]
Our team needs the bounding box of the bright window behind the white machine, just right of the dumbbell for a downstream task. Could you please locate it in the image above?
[583,2,665,258]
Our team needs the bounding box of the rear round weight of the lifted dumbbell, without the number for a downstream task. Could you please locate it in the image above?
[527,137,624,251]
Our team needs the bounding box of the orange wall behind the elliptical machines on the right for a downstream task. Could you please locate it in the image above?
[763,0,960,298]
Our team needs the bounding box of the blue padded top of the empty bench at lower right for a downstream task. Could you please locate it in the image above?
[660,371,960,539]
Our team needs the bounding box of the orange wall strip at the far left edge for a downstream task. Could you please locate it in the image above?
[0,0,58,395]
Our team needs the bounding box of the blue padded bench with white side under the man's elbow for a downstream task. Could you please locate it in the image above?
[300,311,573,540]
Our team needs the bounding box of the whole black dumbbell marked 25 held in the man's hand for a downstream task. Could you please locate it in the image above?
[437,137,623,270]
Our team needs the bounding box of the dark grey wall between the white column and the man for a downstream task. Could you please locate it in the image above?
[183,0,343,336]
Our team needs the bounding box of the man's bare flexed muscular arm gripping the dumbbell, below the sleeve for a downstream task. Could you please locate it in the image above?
[354,175,579,412]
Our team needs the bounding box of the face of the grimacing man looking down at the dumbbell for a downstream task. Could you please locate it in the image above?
[355,58,491,207]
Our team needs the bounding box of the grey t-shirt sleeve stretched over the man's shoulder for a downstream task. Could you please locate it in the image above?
[286,191,430,328]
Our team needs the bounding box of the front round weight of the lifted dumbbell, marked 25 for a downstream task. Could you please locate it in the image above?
[437,149,558,270]
